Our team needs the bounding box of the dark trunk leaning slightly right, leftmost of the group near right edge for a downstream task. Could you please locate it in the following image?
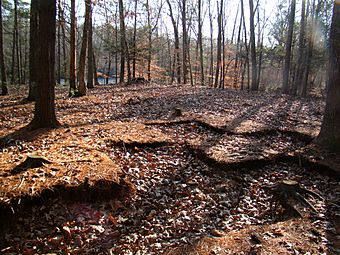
[282,0,296,94]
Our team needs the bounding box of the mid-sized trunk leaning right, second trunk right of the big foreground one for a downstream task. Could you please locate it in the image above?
[77,0,91,96]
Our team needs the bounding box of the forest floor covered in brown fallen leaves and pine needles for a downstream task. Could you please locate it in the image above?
[0,84,340,255]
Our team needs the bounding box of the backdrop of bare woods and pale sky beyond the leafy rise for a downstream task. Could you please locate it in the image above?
[0,0,333,96]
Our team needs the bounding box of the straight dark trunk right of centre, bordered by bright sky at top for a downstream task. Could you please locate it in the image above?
[249,0,259,91]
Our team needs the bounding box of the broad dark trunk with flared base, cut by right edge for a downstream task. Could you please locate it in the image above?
[315,3,340,151]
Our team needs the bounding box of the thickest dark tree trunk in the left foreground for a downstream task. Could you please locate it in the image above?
[30,0,58,129]
